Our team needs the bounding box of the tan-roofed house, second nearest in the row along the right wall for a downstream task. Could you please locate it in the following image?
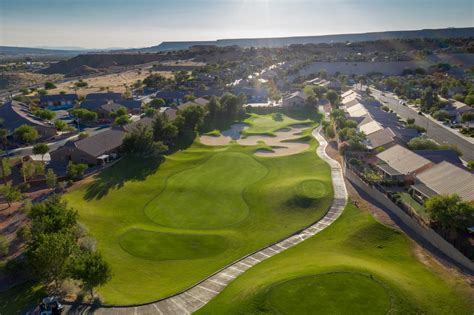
[375,144,433,182]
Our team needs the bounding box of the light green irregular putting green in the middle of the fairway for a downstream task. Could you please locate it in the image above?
[145,152,268,229]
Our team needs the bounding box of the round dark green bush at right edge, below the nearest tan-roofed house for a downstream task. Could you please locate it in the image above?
[425,194,474,237]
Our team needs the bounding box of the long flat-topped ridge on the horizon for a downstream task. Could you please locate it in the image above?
[149,27,474,52]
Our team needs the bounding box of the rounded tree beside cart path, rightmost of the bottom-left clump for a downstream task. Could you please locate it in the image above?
[72,252,112,298]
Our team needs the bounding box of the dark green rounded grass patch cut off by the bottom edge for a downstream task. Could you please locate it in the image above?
[263,272,391,314]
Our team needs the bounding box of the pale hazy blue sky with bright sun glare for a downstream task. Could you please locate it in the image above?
[0,0,474,48]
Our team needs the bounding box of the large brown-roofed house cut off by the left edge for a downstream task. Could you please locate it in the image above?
[0,101,57,139]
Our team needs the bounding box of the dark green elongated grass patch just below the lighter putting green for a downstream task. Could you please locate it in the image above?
[119,230,228,260]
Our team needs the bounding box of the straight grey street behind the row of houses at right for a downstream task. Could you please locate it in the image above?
[371,89,474,161]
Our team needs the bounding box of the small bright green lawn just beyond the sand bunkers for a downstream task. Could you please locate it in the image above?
[243,114,312,136]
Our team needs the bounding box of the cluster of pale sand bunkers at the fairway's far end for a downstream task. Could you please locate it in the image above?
[199,124,309,157]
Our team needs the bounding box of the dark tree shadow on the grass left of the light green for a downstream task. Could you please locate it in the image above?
[84,156,164,201]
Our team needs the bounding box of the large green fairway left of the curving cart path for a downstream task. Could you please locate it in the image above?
[65,115,332,304]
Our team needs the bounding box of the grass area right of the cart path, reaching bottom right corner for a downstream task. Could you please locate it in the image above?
[197,204,474,314]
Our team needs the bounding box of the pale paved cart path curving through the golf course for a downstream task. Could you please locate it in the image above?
[56,128,347,315]
